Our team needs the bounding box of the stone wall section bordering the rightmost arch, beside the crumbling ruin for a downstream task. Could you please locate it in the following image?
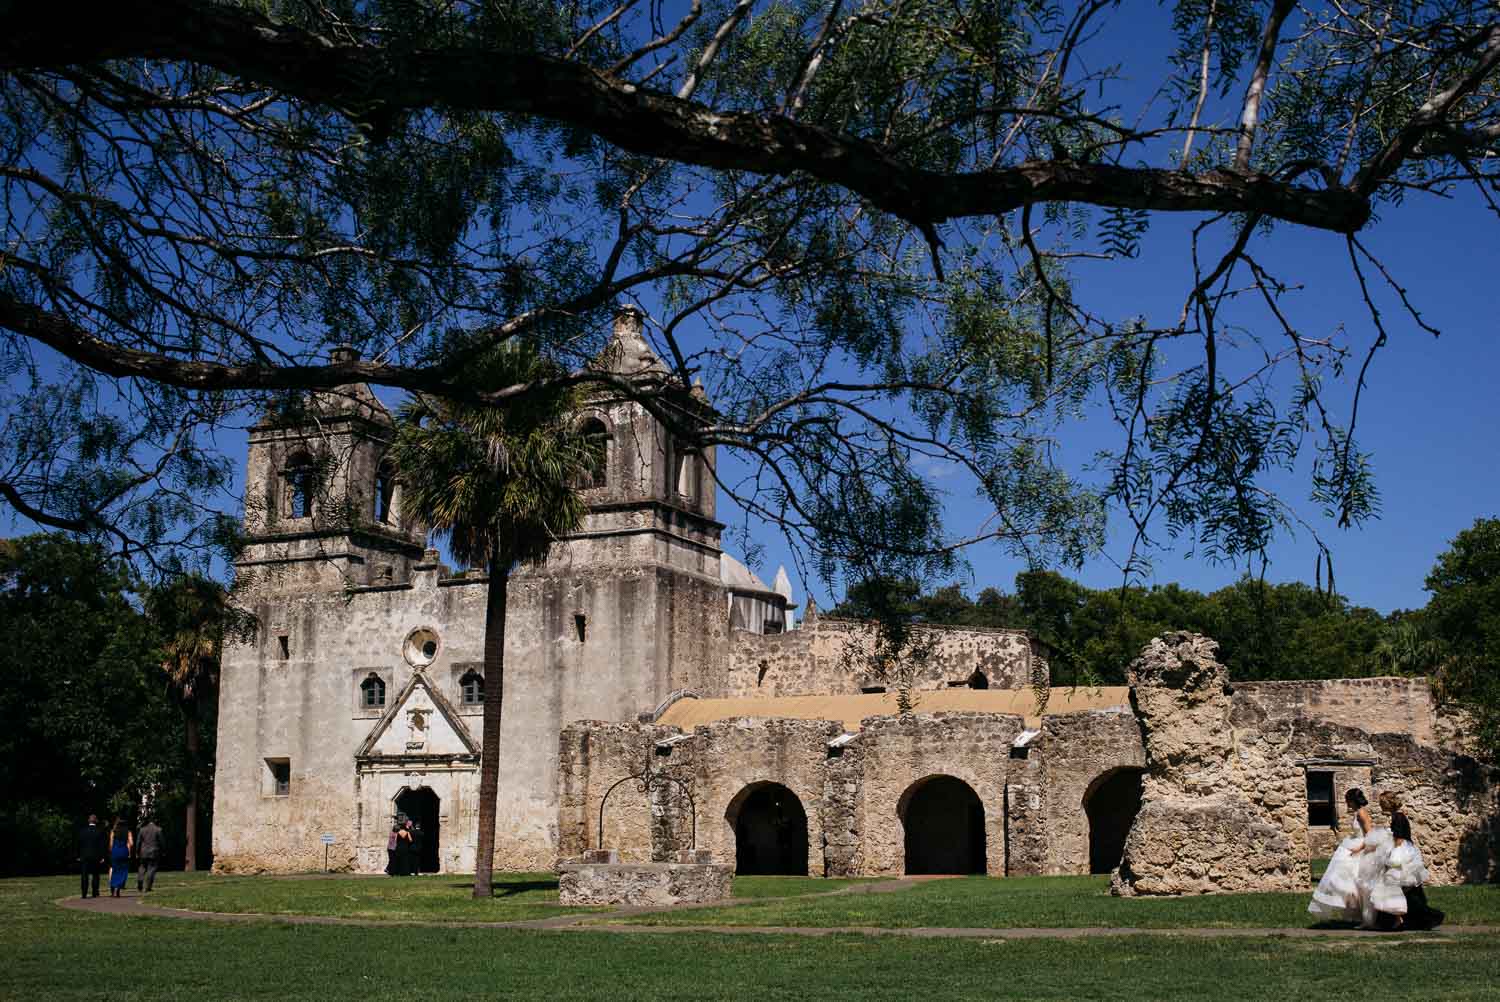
[1038,707,1146,873]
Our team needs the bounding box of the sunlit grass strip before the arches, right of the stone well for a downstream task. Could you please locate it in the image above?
[600,876,1500,929]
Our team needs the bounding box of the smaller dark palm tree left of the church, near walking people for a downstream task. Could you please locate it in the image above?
[146,575,254,870]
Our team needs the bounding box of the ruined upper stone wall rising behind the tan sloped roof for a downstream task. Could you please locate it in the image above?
[725,617,1044,696]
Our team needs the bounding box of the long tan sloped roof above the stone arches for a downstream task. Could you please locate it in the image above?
[657,686,1130,731]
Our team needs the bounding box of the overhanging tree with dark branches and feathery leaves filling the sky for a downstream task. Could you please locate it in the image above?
[0,0,1500,581]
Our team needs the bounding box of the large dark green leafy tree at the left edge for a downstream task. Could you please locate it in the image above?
[0,536,195,873]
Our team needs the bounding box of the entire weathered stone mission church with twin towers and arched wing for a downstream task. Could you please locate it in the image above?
[213,308,1496,890]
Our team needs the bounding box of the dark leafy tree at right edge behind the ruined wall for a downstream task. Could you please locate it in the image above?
[1424,519,1500,756]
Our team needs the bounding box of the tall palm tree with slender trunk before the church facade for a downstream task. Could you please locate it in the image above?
[392,344,599,897]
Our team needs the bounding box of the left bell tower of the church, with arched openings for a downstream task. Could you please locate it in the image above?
[236,348,426,591]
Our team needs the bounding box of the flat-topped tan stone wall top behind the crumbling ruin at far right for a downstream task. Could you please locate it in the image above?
[1233,678,1437,744]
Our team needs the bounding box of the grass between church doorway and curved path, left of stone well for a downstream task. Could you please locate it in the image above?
[149,873,863,923]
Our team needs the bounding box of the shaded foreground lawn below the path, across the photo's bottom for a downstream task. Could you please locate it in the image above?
[0,875,1500,1002]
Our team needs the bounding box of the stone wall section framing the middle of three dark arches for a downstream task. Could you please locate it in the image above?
[857,713,1025,876]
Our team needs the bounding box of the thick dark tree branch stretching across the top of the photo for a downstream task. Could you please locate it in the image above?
[0,0,1370,233]
